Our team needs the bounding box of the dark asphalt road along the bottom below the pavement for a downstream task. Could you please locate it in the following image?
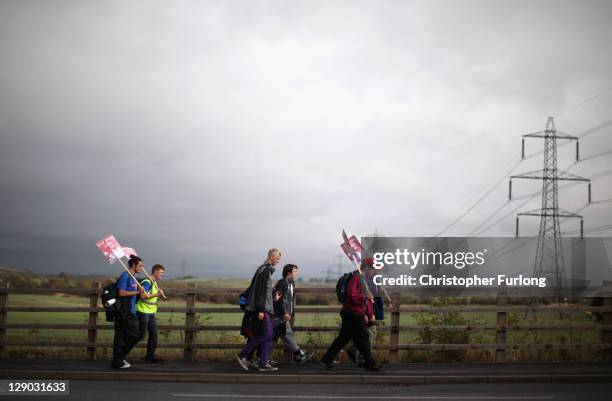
[0,380,612,401]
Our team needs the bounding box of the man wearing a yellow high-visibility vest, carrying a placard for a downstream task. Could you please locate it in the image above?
[136,264,166,363]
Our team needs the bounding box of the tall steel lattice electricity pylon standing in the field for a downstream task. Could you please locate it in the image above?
[508,117,591,295]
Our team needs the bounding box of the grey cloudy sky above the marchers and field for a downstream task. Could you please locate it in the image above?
[0,0,612,277]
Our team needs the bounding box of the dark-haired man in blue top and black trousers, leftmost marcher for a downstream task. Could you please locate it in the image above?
[111,255,146,369]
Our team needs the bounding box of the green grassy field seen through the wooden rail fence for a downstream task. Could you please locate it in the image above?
[6,292,600,362]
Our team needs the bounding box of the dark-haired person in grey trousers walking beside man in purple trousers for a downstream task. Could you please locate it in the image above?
[273,264,313,365]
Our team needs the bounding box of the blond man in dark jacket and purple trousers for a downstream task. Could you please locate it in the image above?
[238,248,281,372]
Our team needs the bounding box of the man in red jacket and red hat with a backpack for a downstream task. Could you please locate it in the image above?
[319,260,380,371]
